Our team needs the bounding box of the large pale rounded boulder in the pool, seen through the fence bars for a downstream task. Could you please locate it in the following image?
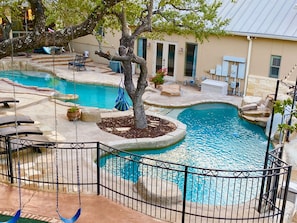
[134,177,183,205]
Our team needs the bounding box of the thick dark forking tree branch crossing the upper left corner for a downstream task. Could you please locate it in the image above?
[0,0,121,59]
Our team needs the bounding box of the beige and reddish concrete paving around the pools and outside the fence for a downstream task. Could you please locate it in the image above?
[0,55,293,223]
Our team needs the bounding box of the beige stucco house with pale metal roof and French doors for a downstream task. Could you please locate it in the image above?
[73,0,297,97]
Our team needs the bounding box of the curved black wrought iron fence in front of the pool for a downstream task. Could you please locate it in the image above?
[0,138,291,223]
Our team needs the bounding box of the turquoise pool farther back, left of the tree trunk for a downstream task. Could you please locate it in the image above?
[0,71,132,109]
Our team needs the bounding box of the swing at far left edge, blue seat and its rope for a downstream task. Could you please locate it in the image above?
[1,39,22,223]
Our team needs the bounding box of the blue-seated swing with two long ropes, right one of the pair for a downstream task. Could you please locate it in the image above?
[51,27,81,223]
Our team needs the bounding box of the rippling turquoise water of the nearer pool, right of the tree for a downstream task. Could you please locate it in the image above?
[101,103,267,204]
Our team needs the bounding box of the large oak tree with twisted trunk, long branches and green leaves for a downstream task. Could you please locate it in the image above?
[0,0,228,129]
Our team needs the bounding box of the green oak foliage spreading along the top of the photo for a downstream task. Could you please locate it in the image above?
[0,0,227,42]
